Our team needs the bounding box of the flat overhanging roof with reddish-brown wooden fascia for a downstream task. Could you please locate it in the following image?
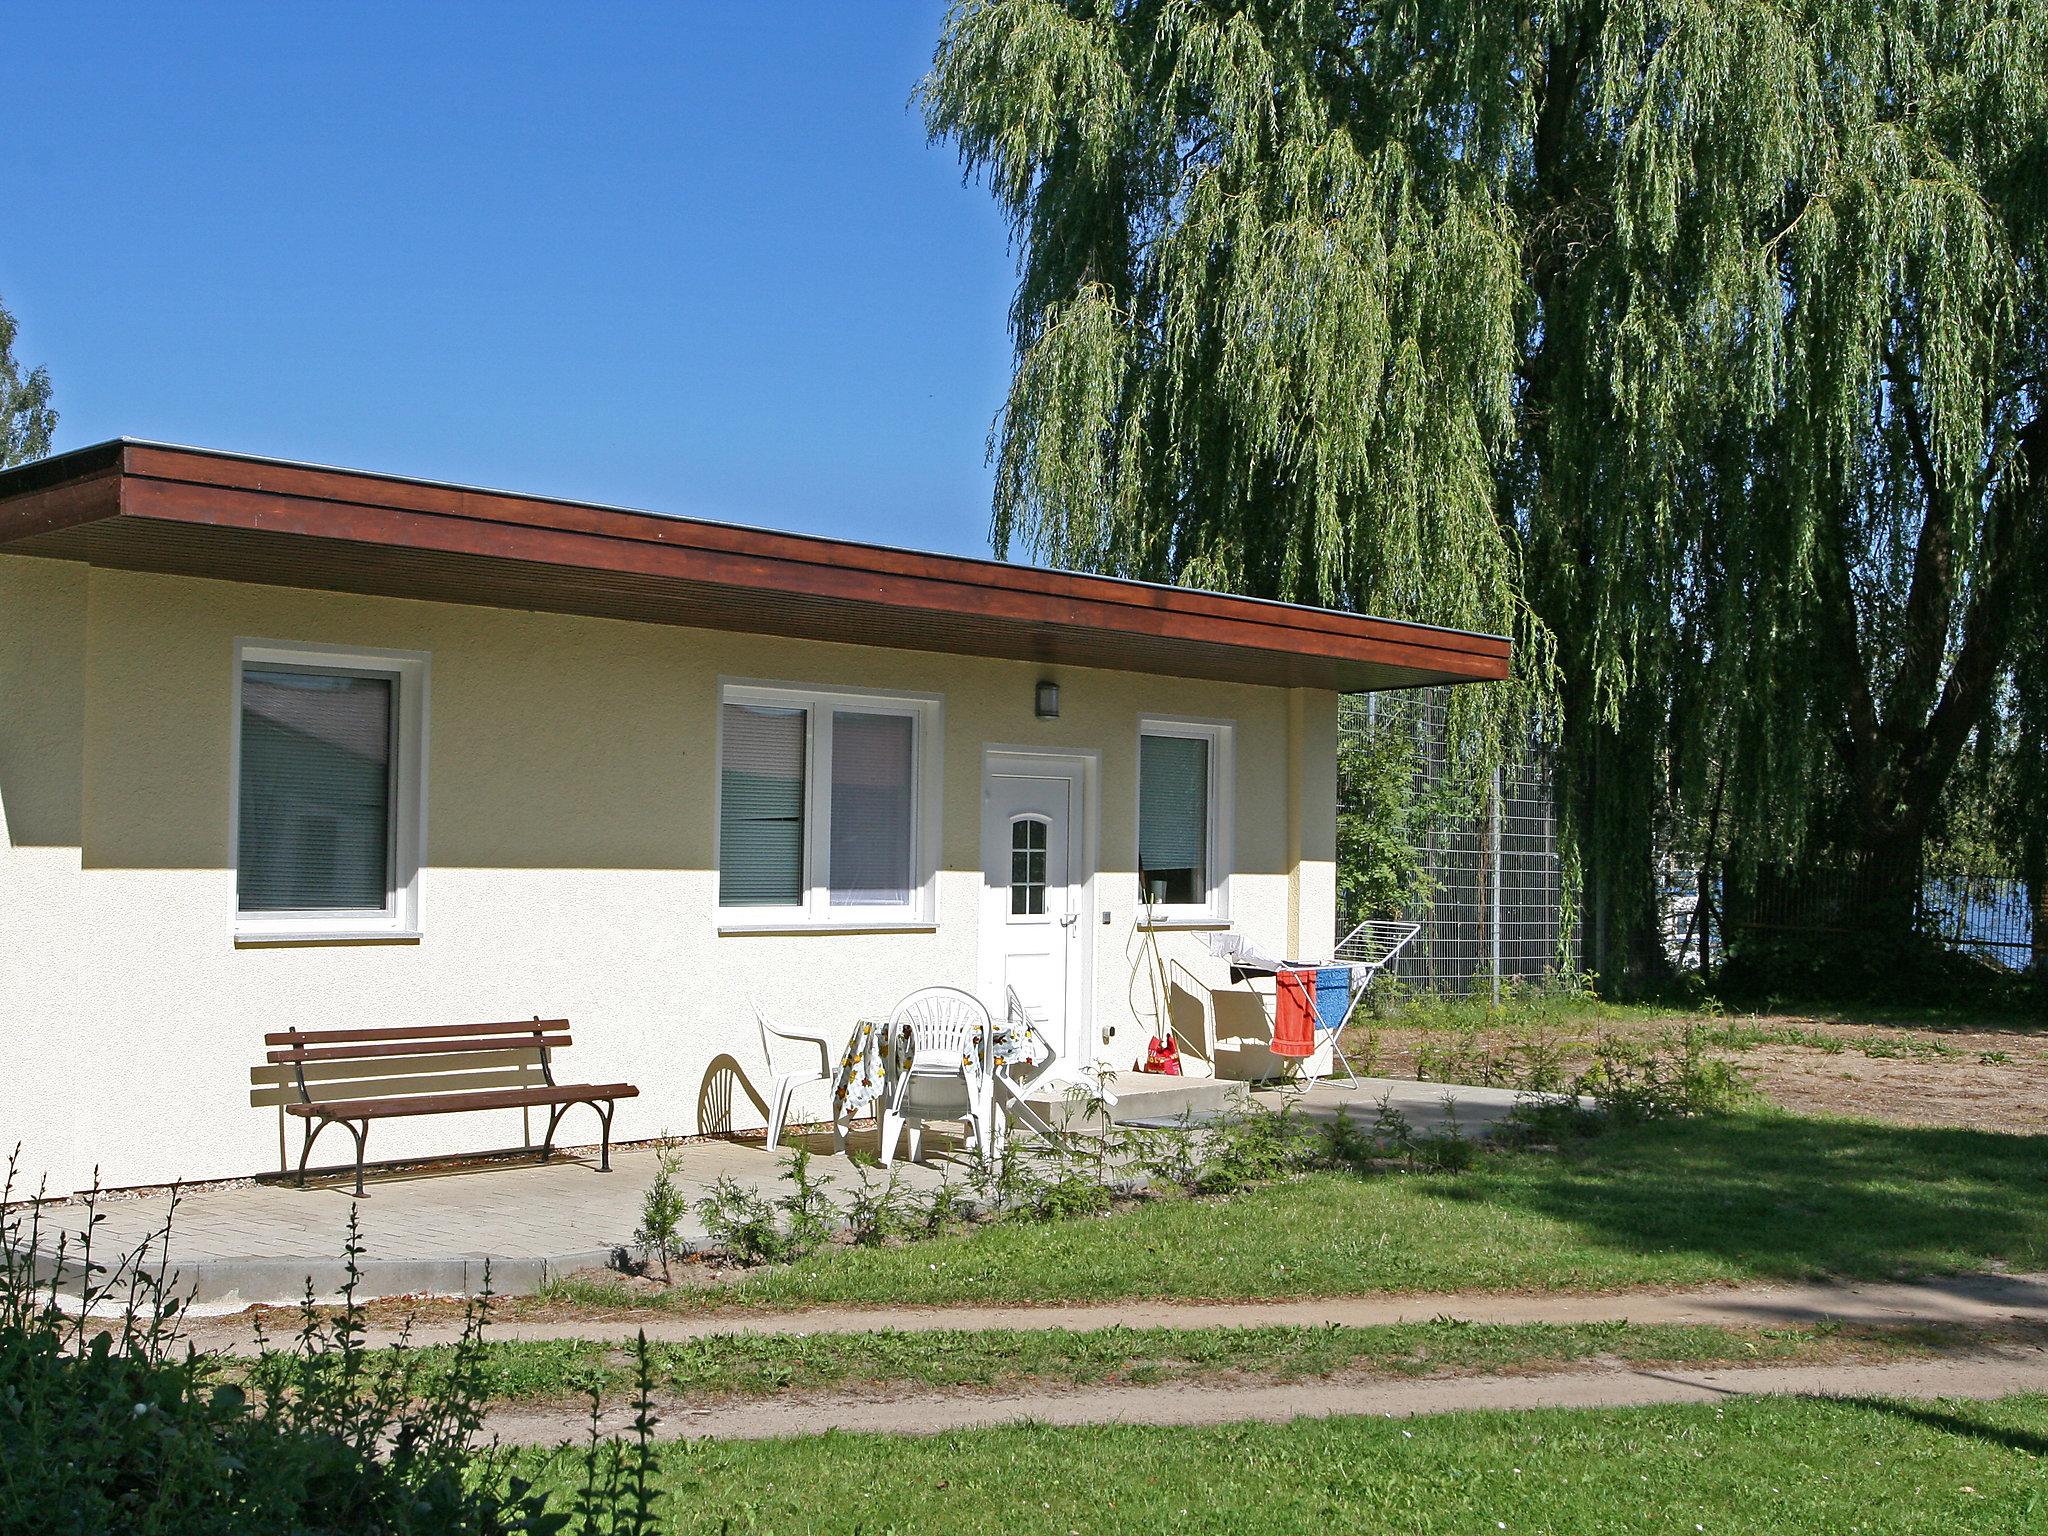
[0,438,1509,692]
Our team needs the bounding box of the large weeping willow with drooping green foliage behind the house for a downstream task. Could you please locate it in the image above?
[924,0,2048,999]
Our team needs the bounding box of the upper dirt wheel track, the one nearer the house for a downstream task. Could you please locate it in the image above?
[190,1274,2048,1354]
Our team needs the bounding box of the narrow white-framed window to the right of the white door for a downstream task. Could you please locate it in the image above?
[1139,721,1231,922]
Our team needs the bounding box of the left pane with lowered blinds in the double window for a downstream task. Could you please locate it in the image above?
[719,702,809,907]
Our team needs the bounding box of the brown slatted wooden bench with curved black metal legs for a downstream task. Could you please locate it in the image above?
[250,1018,639,1196]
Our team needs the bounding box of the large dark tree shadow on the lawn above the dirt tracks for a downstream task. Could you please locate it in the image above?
[1440,1110,2048,1278]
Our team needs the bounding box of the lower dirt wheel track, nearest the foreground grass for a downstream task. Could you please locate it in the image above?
[483,1348,2048,1444]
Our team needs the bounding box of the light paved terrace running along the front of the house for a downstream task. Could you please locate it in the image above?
[19,1077,1518,1311]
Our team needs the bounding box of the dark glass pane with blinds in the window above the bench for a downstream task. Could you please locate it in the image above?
[236,666,399,913]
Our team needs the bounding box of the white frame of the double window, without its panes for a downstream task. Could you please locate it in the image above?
[711,678,944,934]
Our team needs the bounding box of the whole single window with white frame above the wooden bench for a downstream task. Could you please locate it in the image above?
[233,645,426,940]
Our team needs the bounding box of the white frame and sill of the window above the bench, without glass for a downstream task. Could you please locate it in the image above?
[227,639,430,944]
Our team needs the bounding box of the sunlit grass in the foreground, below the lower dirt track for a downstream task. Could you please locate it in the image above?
[507,1397,2048,1536]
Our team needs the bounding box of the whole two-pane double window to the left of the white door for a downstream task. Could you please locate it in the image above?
[719,684,938,928]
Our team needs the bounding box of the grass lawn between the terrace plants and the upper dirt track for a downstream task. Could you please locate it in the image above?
[544,1108,2048,1311]
